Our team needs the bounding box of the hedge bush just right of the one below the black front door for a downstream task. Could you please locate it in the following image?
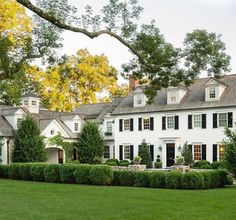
[182,172,204,189]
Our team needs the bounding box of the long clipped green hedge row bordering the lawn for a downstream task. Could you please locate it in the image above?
[0,163,232,189]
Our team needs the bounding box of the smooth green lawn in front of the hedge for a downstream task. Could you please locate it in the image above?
[0,179,236,220]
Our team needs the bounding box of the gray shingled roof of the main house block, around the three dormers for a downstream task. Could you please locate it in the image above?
[112,74,236,115]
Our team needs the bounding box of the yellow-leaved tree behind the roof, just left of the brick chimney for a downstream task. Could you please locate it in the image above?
[28,50,117,111]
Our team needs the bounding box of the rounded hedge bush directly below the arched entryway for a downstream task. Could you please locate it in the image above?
[44,164,61,183]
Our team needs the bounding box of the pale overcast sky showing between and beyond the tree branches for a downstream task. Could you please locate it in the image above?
[59,0,236,79]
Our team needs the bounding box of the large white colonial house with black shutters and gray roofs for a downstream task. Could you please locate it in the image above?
[0,75,236,167]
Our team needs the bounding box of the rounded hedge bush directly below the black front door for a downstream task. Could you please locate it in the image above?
[165,171,183,189]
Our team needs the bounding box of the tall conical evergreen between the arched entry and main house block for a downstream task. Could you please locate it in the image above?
[78,121,103,164]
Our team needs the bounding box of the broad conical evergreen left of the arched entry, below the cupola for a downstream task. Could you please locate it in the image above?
[12,116,46,163]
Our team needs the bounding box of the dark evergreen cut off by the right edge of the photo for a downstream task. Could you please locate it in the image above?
[224,125,236,177]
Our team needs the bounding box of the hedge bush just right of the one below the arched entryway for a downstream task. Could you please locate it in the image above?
[61,163,77,183]
